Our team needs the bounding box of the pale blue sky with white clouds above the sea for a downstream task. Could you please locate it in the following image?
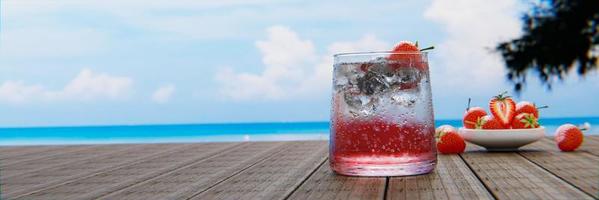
[0,0,599,127]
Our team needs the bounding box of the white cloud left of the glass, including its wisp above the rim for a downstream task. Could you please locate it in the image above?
[216,26,388,100]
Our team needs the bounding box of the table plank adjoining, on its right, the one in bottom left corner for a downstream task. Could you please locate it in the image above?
[14,143,239,200]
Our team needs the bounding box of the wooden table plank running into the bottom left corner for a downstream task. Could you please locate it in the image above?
[0,144,184,199]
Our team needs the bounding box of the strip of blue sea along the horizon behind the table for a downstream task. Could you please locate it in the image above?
[0,117,599,146]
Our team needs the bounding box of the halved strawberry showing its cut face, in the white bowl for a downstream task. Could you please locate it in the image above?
[489,92,516,127]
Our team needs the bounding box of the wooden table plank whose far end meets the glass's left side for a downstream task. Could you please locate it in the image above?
[192,141,328,199]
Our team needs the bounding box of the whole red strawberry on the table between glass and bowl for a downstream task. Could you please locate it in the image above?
[437,126,466,154]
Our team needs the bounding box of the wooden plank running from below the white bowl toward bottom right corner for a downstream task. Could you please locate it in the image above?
[461,144,593,199]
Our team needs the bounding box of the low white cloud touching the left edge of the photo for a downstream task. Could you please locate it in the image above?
[0,69,133,104]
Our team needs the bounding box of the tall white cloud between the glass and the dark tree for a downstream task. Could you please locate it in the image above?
[424,0,520,93]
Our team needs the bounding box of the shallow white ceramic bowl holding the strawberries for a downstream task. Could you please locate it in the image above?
[459,126,545,151]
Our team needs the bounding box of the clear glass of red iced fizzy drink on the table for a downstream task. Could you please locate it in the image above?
[330,52,436,176]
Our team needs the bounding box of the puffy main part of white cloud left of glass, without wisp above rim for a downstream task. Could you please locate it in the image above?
[216,26,316,99]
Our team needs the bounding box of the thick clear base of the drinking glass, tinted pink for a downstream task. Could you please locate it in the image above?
[331,159,437,176]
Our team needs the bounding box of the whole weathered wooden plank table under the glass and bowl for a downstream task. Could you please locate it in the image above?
[0,136,599,199]
